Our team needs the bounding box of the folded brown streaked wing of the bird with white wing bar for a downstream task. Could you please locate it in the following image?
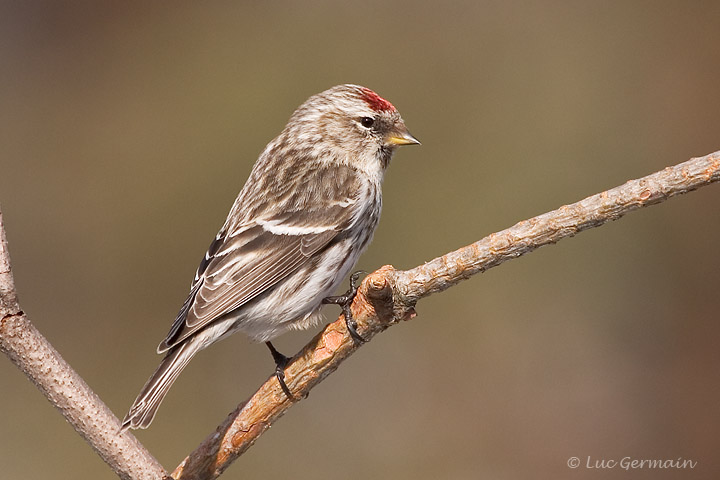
[158,161,364,353]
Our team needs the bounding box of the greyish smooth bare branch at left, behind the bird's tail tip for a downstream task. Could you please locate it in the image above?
[0,211,167,480]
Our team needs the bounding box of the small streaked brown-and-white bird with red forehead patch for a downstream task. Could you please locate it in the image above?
[122,85,420,431]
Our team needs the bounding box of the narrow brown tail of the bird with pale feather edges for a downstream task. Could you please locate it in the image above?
[120,341,201,432]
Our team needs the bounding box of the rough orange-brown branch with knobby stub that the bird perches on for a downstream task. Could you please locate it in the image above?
[172,152,720,479]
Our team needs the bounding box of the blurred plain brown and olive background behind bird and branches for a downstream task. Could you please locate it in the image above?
[0,1,720,479]
